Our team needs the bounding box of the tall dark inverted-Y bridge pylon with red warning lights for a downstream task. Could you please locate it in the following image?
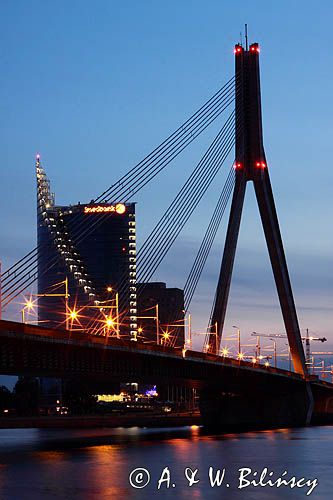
[209,43,306,376]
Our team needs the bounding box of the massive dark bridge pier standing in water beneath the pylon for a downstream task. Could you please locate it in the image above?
[199,377,312,432]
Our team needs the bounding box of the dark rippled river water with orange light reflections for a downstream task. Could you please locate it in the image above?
[0,426,333,500]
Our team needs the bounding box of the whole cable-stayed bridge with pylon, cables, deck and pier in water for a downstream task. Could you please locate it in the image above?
[0,43,333,426]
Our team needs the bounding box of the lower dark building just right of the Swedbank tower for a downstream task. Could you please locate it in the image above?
[137,282,185,348]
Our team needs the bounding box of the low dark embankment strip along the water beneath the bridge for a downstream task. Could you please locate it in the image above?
[0,413,201,429]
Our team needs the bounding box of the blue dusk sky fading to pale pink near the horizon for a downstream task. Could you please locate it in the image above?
[0,0,333,386]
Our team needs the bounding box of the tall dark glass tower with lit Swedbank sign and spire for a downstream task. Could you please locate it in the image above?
[36,156,137,338]
